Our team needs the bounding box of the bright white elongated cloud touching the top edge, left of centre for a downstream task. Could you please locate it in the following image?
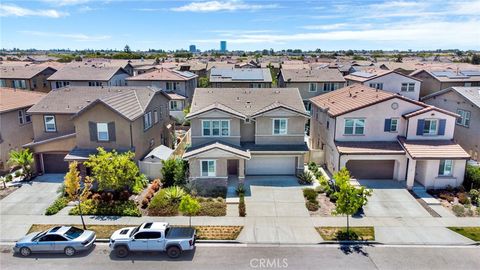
[172,0,278,12]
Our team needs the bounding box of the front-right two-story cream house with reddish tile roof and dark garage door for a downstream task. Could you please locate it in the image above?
[310,84,469,188]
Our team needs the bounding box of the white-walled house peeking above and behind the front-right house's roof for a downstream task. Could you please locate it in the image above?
[345,68,422,100]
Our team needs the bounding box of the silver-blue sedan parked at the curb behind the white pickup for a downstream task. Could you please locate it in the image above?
[13,226,96,257]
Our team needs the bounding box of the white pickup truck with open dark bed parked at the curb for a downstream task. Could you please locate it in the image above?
[109,222,195,258]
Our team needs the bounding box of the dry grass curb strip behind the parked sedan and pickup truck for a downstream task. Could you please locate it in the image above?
[28,224,243,240]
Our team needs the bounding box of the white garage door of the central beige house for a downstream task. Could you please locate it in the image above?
[246,157,295,175]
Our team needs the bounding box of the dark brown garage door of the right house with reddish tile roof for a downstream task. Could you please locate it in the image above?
[347,160,395,179]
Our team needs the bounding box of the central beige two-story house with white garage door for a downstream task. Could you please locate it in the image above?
[183,88,309,184]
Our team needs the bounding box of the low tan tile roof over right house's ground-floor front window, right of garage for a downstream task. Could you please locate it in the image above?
[398,137,470,159]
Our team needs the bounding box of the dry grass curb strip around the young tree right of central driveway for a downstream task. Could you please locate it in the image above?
[316,227,375,241]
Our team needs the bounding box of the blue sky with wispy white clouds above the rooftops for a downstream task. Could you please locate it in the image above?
[0,0,480,50]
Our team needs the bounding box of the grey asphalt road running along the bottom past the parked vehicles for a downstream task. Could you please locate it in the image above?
[0,244,480,270]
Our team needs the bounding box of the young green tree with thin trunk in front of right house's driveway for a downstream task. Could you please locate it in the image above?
[333,168,372,239]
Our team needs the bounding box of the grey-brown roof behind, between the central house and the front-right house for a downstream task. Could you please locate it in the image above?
[281,68,345,82]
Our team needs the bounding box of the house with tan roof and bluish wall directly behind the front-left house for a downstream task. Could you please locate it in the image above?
[48,64,130,89]
